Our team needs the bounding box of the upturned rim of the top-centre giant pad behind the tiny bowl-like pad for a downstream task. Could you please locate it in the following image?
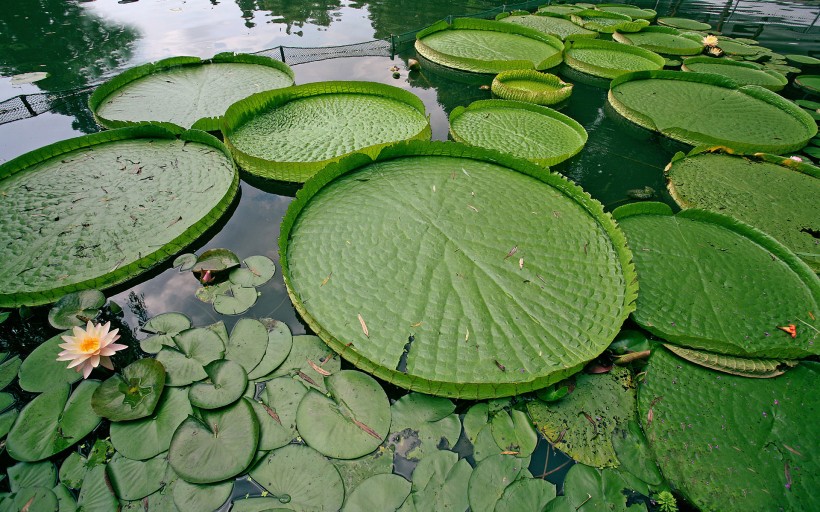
[416,18,563,73]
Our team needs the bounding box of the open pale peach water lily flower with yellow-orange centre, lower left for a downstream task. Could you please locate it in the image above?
[57,320,128,379]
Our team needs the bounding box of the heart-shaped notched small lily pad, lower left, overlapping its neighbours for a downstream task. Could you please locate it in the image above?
[168,399,259,484]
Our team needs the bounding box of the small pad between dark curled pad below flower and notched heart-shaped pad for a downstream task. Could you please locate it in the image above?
[111,387,193,460]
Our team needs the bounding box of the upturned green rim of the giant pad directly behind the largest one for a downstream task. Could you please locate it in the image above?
[221,81,432,183]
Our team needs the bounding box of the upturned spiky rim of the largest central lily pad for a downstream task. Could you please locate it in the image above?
[279,141,638,400]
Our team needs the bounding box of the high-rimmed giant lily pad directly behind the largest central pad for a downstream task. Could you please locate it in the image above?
[222,82,431,182]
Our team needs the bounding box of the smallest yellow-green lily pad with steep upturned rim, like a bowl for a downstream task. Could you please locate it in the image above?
[492,69,573,105]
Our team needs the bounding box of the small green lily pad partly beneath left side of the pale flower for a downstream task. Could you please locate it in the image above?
[18,331,83,393]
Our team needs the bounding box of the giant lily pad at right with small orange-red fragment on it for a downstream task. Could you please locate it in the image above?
[615,203,820,359]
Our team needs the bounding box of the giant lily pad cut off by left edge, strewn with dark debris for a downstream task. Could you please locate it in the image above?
[0,126,239,306]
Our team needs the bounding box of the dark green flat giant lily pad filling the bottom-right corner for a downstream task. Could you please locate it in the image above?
[638,348,820,512]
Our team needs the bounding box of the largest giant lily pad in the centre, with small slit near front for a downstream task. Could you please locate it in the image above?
[280,143,636,398]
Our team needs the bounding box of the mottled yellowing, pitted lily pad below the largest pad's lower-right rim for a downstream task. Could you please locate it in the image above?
[527,366,635,467]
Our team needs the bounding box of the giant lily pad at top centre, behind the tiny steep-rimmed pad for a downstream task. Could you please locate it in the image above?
[416,18,561,73]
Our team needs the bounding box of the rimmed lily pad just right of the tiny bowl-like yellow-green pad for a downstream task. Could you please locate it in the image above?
[564,39,666,78]
